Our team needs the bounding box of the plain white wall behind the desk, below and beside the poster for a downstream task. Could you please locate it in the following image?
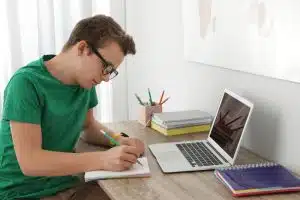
[126,0,300,172]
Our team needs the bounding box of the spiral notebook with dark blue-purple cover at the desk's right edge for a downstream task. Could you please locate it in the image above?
[215,163,300,197]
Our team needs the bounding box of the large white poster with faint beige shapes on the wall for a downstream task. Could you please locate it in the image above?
[182,0,300,82]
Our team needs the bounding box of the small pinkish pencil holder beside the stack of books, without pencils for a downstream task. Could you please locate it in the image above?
[138,104,162,126]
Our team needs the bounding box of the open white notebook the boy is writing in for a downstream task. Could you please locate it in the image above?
[84,157,150,182]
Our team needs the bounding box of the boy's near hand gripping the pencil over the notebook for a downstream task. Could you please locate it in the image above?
[94,145,140,171]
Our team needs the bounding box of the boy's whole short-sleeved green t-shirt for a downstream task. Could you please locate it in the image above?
[0,55,98,200]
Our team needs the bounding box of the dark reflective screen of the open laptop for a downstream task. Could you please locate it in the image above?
[210,93,250,157]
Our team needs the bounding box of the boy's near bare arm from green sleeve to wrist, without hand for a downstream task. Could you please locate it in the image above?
[10,121,105,176]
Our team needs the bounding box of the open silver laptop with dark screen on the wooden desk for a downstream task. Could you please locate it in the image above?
[149,89,253,173]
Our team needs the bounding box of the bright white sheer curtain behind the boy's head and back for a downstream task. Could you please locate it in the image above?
[0,0,112,122]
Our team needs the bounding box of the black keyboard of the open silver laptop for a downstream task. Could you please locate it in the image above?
[176,142,222,167]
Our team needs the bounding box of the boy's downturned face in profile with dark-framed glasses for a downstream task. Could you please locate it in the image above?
[76,41,124,88]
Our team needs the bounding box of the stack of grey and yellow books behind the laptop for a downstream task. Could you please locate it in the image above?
[151,110,212,136]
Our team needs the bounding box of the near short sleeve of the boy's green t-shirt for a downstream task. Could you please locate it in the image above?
[3,74,42,124]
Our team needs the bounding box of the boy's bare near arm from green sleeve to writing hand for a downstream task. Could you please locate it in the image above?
[10,121,139,176]
